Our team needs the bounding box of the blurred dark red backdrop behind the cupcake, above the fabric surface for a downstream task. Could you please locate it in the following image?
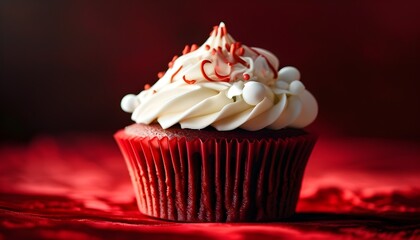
[0,0,420,140]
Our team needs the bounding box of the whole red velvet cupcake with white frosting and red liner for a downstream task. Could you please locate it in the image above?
[114,23,318,222]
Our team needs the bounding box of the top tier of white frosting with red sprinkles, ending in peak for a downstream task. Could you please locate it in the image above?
[154,22,279,88]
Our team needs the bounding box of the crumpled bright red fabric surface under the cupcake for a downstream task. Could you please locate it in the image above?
[0,135,420,239]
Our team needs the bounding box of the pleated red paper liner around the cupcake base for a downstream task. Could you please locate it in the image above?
[114,130,316,222]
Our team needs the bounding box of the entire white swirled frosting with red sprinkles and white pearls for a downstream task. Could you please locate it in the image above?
[121,23,318,131]
